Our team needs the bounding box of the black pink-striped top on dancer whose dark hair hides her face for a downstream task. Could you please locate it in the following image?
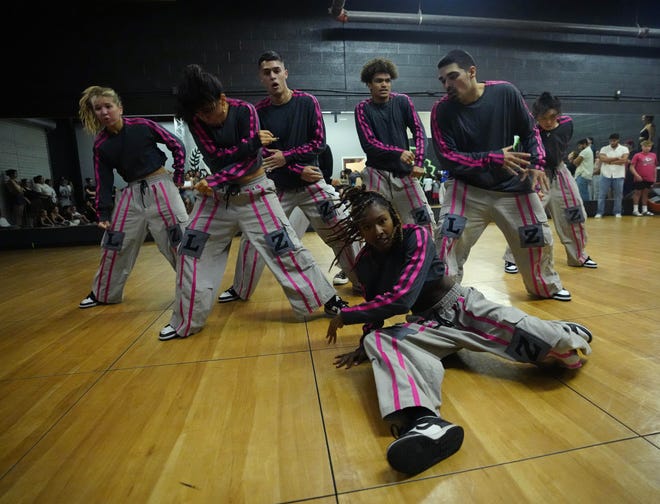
[188,98,262,188]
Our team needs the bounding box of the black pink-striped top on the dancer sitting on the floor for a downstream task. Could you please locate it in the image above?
[341,224,444,331]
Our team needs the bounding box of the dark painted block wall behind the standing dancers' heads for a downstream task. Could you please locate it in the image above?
[5,0,660,163]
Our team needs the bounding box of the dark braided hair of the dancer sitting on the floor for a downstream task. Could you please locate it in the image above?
[330,186,403,267]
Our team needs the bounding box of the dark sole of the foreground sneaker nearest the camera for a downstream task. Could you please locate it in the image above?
[387,425,464,474]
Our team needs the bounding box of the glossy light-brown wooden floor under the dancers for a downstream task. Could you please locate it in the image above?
[0,216,660,504]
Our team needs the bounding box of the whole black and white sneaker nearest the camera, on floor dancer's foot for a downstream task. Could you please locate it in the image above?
[387,416,464,474]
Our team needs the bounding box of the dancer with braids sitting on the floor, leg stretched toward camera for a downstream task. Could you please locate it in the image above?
[326,188,592,474]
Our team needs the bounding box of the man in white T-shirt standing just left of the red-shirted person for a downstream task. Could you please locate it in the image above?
[595,133,629,219]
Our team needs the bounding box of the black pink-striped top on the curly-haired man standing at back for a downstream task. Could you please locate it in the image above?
[355,93,426,177]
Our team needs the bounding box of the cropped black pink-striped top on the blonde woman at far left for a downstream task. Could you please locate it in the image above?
[93,117,186,222]
